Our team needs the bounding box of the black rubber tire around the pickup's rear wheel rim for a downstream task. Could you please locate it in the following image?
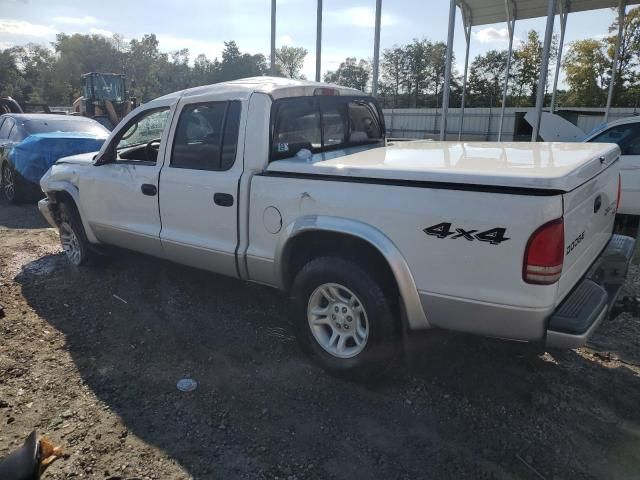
[291,257,400,379]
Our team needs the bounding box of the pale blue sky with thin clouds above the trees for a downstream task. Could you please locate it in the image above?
[0,0,615,86]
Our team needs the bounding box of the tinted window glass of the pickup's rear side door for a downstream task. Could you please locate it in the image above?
[171,101,241,171]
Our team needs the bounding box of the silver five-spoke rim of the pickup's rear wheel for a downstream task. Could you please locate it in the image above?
[307,283,369,358]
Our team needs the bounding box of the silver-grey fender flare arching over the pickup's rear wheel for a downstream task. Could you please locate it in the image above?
[275,215,430,329]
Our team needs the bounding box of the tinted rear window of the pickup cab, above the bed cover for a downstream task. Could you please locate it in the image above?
[271,96,384,160]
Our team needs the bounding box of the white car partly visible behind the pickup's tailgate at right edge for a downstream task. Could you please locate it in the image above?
[585,116,640,231]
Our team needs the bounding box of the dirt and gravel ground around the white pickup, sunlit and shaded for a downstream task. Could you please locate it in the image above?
[0,203,640,479]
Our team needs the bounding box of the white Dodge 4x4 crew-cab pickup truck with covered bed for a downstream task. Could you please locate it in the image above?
[39,77,634,373]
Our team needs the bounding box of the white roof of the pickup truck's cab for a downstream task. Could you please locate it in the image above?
[151,77,365,100]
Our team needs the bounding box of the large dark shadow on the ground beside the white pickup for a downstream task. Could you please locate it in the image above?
[15,251,640,479]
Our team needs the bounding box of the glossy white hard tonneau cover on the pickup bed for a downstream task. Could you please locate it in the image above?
[267,140,620,192]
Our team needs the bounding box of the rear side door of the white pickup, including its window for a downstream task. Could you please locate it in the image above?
[160,100,243,276]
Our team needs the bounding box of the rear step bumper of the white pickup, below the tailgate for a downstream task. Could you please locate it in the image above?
[545,235,635,348]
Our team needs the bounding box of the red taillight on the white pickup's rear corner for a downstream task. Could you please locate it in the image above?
[522,218,564,285]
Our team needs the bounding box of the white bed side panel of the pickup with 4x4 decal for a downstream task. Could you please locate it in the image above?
[247,175,562,335]
